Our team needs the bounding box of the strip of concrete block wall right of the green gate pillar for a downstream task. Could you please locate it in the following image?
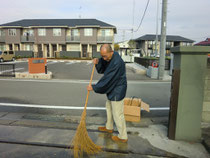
[202,67,210,123]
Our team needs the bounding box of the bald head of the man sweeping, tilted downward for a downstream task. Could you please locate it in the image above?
[100,44,114,61]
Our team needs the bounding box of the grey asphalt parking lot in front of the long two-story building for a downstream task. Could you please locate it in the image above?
[4,60,151,80]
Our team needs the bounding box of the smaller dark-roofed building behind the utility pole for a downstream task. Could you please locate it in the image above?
[134,34,194,56]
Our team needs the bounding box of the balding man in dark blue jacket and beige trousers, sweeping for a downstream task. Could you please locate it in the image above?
[87,44,128,142]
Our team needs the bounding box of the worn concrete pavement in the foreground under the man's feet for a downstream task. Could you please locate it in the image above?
[0,113,209,158]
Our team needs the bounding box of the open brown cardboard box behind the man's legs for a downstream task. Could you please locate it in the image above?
[124,98,150,122]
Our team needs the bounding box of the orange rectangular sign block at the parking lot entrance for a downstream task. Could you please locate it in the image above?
[28,58,47,74]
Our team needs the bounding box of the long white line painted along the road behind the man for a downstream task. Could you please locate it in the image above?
[0,103,169,111]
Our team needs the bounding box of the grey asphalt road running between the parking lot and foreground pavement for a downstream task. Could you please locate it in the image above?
[0,79,170,115]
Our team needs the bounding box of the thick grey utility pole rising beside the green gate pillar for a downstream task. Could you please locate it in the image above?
[158,0,167,80]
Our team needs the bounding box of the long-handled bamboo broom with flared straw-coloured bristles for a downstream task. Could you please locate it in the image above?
[71,65,102,158]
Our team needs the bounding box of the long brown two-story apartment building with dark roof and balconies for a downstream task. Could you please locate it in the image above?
[0,19,116,58]
